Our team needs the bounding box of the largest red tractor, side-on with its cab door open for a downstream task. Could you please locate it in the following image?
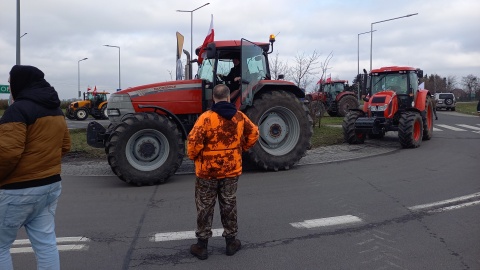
[87,35,313,186]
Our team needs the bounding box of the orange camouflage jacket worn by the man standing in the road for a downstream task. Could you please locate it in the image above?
[187,107,259,179]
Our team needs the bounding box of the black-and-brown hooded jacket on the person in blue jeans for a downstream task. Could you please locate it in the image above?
[0,65,70,189]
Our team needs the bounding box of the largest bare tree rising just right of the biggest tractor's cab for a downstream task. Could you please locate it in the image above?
[290,50,320,89]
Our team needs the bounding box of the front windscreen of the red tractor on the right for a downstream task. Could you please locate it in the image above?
[372,73,408,94]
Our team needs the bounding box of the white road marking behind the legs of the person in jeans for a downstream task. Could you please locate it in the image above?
[10,236,90,254]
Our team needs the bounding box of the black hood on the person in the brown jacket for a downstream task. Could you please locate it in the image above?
[10,65,60,108]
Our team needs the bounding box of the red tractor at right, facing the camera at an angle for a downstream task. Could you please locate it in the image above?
[342,66,434,148]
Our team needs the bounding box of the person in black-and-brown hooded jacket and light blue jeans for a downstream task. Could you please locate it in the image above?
[0,65,70,270]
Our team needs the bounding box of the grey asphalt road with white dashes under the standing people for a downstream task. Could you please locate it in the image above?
[12,112,480,270]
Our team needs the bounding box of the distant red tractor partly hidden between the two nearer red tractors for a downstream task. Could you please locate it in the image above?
[305,79,360,117]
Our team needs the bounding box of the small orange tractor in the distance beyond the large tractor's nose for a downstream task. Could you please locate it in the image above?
[65,91,110,121]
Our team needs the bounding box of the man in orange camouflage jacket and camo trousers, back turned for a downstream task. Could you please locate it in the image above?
[187,84,259,260]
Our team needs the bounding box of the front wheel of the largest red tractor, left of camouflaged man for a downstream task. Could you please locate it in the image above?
[105,113,185,186]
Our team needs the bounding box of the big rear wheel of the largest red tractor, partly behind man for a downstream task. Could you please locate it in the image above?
[245,90,313,171]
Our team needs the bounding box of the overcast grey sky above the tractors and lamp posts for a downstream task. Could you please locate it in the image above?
[0,0,480,99]
